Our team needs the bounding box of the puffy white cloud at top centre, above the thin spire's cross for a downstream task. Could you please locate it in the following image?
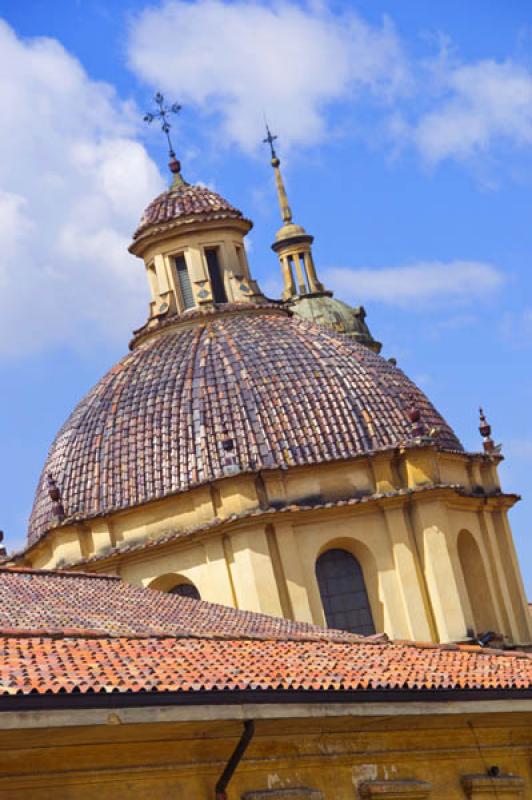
[129,0,408,150]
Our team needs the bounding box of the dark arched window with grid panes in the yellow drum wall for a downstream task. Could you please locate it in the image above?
[316,549,375,636]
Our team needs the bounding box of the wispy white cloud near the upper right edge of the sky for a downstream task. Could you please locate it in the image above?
[414,60,532,163]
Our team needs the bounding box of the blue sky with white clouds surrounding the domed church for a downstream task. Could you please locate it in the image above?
[0,0,532,596]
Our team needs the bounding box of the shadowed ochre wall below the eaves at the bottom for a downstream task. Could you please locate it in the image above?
[0,707,532,800]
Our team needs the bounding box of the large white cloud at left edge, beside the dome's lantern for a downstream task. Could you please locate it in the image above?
[0,21,161,355]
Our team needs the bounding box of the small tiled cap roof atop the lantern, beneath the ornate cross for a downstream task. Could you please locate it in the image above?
[133,183,244,240]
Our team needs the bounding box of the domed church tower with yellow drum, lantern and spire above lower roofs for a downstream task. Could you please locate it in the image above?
[16,101,532,646]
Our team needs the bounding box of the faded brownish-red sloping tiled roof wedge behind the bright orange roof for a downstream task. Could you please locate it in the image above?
[0,567,357,640]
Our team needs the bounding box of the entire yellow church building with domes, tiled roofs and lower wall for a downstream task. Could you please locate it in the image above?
[0,117,532,800]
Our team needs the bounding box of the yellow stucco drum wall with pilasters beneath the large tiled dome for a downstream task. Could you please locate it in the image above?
[20,446,532,646]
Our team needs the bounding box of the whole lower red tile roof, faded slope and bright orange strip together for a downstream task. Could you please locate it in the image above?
[0,568,532,696]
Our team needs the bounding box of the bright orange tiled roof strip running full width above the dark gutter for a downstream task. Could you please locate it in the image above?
[0,636,532,699]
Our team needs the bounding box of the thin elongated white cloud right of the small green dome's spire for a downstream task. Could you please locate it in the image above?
[323,261,504,310]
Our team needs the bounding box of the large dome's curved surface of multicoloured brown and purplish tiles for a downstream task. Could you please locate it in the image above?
[29,305,462,543]
